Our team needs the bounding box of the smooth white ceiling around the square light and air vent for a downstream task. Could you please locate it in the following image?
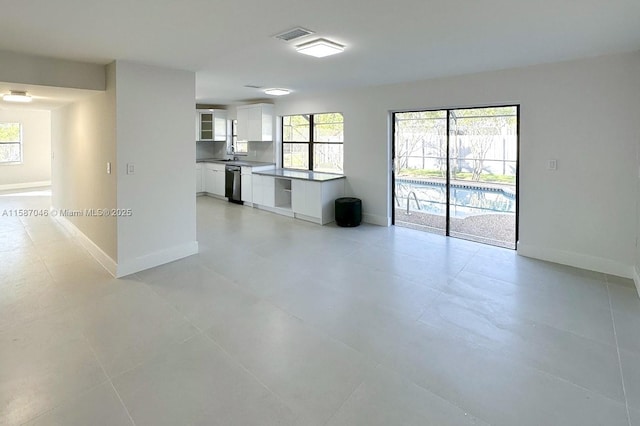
[0,0,640,104]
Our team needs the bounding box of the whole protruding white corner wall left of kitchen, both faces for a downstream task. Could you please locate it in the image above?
[52,61,198,276]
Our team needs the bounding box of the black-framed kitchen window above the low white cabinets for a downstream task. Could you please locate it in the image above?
[282,112,344,173]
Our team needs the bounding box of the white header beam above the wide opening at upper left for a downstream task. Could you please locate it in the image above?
[0,50,105,90]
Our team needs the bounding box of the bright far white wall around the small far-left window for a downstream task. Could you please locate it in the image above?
[0,108,51,189]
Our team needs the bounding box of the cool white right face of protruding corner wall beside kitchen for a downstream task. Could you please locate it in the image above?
[115,61,198,276]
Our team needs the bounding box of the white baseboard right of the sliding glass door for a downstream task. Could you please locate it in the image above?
[518,242,638,280]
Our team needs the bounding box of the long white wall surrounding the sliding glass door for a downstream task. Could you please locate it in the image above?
[276,52,640,276]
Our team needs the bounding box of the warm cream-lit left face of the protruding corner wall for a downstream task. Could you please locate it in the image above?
[51,60,118,264]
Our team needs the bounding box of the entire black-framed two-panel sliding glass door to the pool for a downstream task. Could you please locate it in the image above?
[392,105,520,249]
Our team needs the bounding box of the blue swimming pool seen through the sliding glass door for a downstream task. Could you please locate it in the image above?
[395,179,516,218]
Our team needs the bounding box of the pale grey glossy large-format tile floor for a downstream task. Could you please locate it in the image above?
[0,191,640,426]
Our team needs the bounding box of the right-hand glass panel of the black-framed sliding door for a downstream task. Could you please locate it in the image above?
[449,107,518,248]
